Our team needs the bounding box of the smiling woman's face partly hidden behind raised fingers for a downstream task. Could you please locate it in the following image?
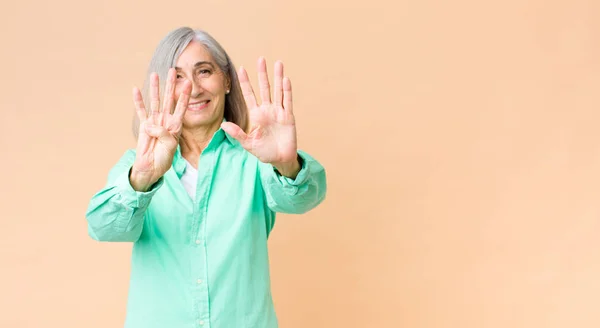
[175,40,229,129]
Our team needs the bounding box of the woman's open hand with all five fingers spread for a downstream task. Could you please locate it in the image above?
[221,57,300,178]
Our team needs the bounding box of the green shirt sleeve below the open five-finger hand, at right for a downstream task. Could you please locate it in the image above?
[259,150,327,214]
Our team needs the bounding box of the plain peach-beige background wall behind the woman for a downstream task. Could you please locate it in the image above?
[0,0,600,328]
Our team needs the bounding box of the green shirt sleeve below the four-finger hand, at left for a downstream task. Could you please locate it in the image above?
[86,149,164,242]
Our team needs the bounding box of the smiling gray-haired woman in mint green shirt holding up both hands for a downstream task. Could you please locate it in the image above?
[86,28,326,328]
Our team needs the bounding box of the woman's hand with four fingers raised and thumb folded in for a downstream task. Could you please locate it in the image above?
[129,68,192,191]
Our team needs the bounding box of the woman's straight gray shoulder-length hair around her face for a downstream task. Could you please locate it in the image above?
[132,27,248,139]
